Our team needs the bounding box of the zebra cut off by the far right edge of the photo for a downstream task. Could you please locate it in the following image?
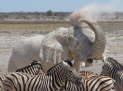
[101,57,123,91]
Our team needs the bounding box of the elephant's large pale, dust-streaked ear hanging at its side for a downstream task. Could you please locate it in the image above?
[40,35,73,68]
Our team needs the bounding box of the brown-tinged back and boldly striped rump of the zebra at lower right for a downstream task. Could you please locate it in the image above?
[81,71,114,91]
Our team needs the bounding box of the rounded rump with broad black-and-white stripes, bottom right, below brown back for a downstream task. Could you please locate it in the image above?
[85,76,115,91]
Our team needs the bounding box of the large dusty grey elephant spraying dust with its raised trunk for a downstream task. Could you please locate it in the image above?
[8,9,106,72]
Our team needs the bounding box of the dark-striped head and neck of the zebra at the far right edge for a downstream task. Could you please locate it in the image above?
[101,57,123,76]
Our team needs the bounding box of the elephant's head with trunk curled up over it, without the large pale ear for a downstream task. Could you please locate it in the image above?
[57,11,106,70]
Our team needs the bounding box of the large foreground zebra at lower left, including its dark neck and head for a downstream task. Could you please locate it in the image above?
[3,60,80,91]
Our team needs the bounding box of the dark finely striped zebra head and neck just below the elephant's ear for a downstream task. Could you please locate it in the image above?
[47,60,81,86]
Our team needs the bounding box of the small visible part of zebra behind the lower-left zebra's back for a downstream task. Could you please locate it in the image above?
[16,61,43,75]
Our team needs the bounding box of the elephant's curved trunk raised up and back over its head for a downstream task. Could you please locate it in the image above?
[80,20,106,60]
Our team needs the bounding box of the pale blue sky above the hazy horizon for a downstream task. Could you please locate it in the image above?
[0,0,123,12]
